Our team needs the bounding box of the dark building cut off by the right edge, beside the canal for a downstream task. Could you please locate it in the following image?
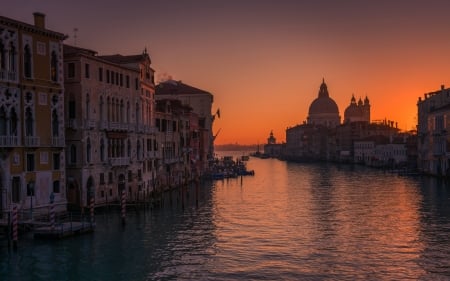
[417,85,450,176]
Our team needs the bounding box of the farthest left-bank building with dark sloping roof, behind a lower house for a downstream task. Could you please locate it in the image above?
[155,80,215,171]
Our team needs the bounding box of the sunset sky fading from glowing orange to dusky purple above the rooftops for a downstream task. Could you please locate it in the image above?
[5,0,450,144]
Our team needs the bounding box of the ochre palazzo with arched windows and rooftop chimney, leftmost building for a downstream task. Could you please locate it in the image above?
[0,13,66,216]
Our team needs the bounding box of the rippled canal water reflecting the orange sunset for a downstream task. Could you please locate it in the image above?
[0,154,450,281]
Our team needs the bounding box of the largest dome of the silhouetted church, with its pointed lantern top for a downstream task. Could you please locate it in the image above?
[307,79,341,128]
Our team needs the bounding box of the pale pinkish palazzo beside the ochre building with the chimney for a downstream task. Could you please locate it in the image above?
[64,45,158,208]
